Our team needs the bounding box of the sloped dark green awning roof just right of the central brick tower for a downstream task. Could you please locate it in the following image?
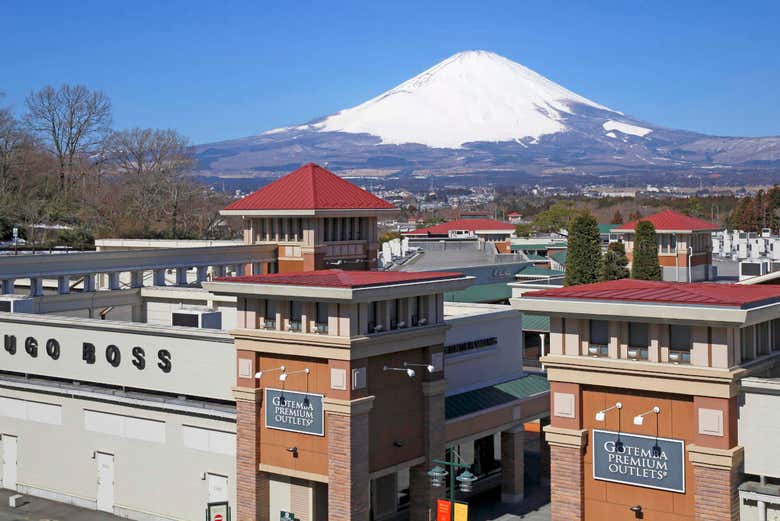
[444,374,550,420]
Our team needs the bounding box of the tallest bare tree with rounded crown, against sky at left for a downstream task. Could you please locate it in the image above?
[25,85,111,189]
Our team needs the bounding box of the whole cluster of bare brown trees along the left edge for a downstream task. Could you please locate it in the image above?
[0,85,234,247]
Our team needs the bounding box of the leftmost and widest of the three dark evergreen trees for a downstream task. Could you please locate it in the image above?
[564,214,601,286]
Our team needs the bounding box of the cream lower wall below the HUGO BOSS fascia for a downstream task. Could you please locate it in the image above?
[0,388,235,520]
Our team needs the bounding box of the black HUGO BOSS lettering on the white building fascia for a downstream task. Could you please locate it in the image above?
[3,335,173,373]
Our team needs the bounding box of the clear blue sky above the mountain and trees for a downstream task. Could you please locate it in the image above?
[0,0,780,143]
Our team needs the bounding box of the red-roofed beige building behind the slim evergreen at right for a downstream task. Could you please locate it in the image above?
[612,210,719,282]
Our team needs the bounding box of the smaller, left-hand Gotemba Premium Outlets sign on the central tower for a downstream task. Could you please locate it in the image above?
[265,389,325,436]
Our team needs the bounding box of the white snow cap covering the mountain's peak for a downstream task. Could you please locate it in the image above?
[313,51,615,148]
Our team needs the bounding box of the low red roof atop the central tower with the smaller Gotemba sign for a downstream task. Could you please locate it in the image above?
[214,270,464,288]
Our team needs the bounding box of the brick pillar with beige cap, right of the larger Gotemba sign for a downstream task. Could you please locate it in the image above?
[688,445,744,521]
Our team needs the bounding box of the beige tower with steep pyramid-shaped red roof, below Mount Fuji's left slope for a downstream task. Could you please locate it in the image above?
[222,163,397,273]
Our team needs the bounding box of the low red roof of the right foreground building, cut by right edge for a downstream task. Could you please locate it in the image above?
[523,279,780,308]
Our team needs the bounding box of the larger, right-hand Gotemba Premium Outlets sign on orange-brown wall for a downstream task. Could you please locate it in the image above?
[593,429,685,493]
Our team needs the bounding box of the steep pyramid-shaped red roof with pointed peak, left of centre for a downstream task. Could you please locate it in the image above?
[225,163,395,210]
